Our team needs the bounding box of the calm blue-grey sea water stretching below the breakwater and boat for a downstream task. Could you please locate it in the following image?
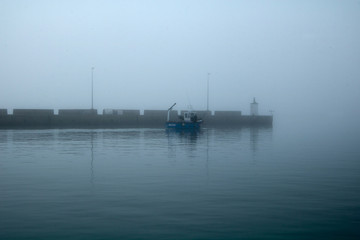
[0,124,360,239]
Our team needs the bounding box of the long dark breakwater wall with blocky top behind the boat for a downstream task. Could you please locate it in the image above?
[0,109,273,129]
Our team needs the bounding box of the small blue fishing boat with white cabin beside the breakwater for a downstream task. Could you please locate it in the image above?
[166,103,203,129]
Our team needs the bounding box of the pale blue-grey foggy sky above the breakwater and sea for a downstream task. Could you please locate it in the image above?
[0,0,360,121]
